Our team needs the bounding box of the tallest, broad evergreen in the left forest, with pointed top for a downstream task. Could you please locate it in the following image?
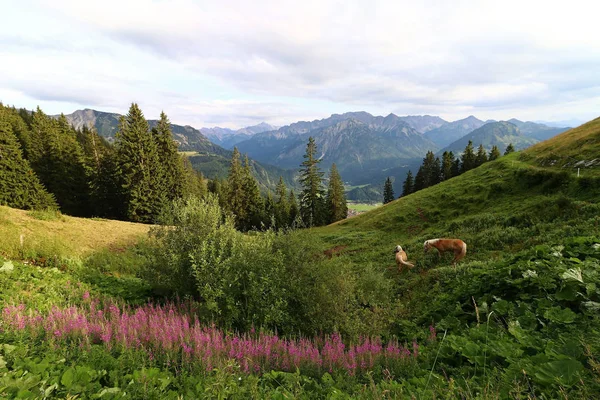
[115,103,163,223]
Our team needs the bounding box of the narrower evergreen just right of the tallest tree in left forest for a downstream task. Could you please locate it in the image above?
[152,112,186,204]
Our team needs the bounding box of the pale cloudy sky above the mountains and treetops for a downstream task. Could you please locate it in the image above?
[0,0,600,128]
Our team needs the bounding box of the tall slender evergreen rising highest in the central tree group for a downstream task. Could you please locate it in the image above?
[300,137,325,227]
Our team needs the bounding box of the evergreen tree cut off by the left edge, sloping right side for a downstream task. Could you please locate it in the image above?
[0,109,57,209]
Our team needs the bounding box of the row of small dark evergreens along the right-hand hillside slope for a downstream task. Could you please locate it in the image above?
[383,140,515,204]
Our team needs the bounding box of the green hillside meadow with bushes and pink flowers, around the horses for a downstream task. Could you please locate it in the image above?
[0,120,600,399]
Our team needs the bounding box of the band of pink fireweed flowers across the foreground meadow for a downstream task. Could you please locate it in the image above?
[0,302,419,375]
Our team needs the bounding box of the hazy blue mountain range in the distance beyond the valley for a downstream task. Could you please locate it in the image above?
[61,109,568,200]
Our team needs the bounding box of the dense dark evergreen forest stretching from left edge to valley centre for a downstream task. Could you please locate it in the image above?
[0,103,347,231]
